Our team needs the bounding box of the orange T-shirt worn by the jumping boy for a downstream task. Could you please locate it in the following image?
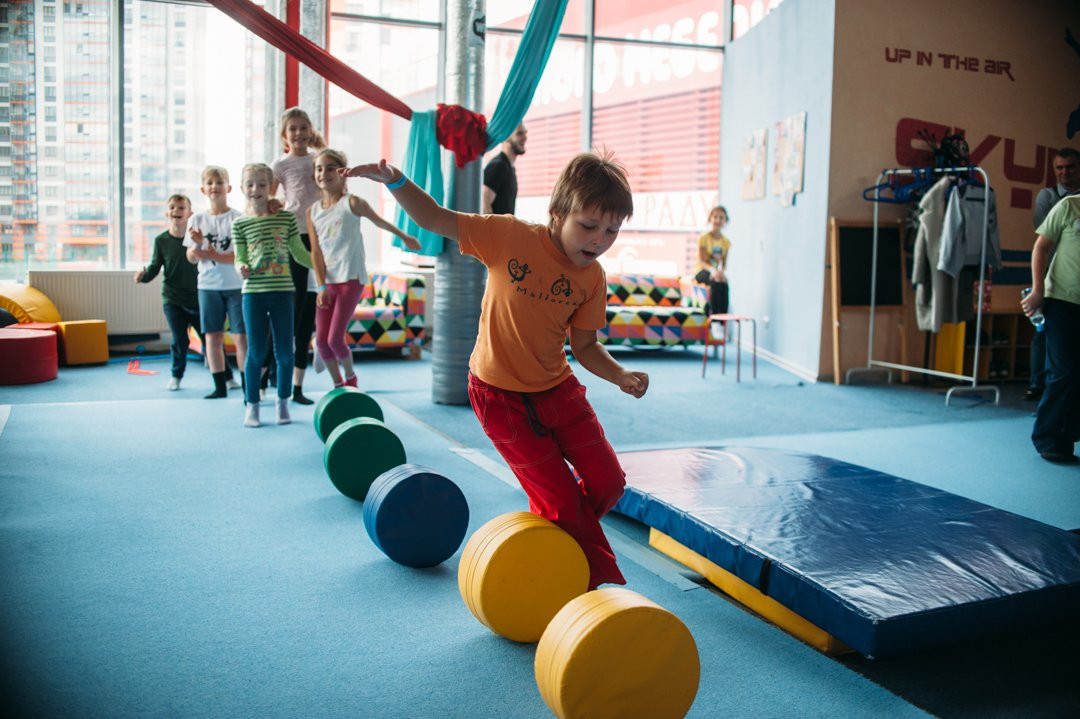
[458,215,607,392]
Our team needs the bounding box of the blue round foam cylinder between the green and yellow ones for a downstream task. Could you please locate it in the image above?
[364,464,469,568]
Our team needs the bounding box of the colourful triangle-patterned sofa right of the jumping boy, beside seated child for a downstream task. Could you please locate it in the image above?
[596,274,708,347]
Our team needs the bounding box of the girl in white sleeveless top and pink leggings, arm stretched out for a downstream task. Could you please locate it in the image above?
[308,149,420,386]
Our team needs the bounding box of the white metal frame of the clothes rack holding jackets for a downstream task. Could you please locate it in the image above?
[845,165,1001,405]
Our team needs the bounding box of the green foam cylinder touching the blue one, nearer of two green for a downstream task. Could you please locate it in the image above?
[323,417,405,502]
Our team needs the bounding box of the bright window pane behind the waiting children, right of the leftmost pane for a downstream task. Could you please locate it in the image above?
[124,0,272,266]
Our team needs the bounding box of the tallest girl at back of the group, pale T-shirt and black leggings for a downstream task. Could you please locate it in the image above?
[267,107,326,405]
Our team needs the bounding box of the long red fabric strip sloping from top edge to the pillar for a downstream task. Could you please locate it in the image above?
[206,0,413,120]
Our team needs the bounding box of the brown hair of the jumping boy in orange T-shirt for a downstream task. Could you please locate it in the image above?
[548,152,634,219]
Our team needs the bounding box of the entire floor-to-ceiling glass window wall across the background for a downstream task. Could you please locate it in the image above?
[0,0,730,277]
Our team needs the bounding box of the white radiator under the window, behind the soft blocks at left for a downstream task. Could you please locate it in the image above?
[29,270,168,335]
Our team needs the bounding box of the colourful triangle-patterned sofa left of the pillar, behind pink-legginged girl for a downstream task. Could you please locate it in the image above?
[346,272,426,360]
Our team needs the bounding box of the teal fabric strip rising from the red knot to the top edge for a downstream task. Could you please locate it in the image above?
[487,0,567,150]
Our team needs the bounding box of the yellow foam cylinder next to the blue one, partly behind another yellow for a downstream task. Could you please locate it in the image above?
[458,512,589,641]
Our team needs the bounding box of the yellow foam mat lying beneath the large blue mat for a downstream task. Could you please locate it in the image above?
[649,529,851,654]
